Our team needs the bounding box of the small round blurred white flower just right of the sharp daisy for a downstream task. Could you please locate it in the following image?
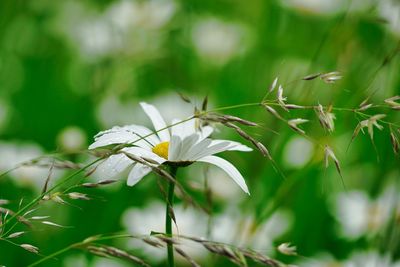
[283,136,314,168]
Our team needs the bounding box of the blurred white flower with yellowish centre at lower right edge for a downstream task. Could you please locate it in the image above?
[334,185,400,239]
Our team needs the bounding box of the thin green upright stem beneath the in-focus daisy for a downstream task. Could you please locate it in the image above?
[165,166,178,267]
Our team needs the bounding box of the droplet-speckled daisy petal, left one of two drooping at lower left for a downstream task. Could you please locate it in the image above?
[96,154,134,180]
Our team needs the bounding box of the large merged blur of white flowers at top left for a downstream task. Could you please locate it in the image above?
[55,0,177,61]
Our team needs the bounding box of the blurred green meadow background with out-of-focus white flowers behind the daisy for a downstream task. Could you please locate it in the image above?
[0,0,400,266]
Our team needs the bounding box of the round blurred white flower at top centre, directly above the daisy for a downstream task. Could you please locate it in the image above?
[191,18,249,65]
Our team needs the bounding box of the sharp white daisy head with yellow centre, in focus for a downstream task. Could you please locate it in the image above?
[89,102,252,194]
